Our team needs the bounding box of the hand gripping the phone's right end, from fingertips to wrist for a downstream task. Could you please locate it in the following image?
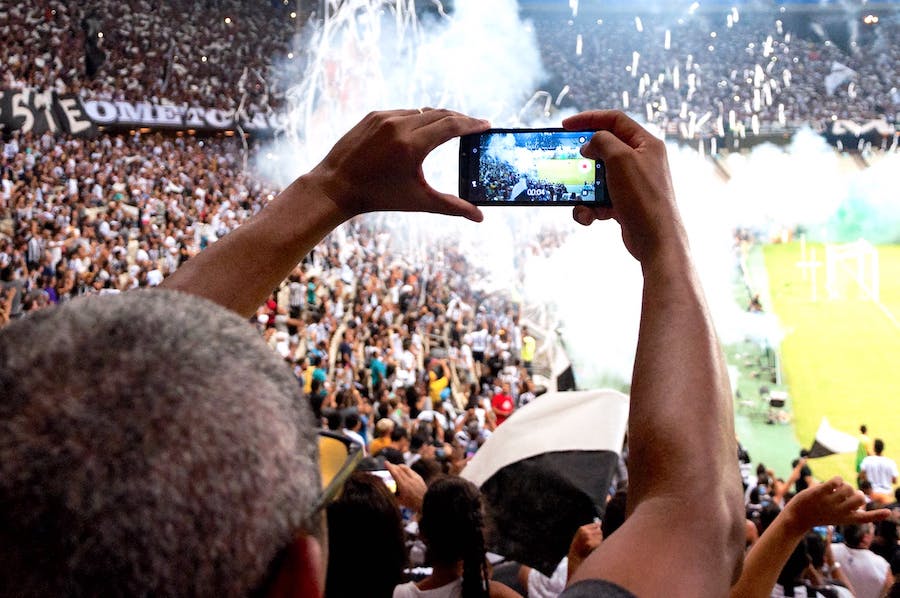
[562,110,687,264]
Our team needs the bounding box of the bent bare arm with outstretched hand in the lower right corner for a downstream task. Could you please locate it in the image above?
[731,478,891,598]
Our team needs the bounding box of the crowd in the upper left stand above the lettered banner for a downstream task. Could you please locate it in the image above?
[0,0,302,112]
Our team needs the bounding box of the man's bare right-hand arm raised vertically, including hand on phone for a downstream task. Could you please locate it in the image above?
[563,111,744,596]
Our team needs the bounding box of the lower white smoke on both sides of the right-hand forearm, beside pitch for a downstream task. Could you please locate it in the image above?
[525,131,900,384]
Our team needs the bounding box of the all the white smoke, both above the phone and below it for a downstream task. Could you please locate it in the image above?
[256,0,900,385]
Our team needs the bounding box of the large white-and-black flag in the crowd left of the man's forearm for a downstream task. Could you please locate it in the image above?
[462,390,628,576]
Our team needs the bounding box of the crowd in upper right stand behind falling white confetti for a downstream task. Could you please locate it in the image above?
[534,6,900,135]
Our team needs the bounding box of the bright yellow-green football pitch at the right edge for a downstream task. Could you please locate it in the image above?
[751,242,900,480]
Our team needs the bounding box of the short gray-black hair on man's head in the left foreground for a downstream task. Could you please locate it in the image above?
[0,289,320,596]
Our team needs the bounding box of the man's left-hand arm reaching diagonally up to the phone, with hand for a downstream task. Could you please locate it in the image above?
[162,109,489,317]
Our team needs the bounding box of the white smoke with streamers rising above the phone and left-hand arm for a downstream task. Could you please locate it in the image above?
[256,0,544,191]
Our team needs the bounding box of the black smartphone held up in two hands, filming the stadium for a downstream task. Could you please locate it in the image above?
[459,128,611,207]
